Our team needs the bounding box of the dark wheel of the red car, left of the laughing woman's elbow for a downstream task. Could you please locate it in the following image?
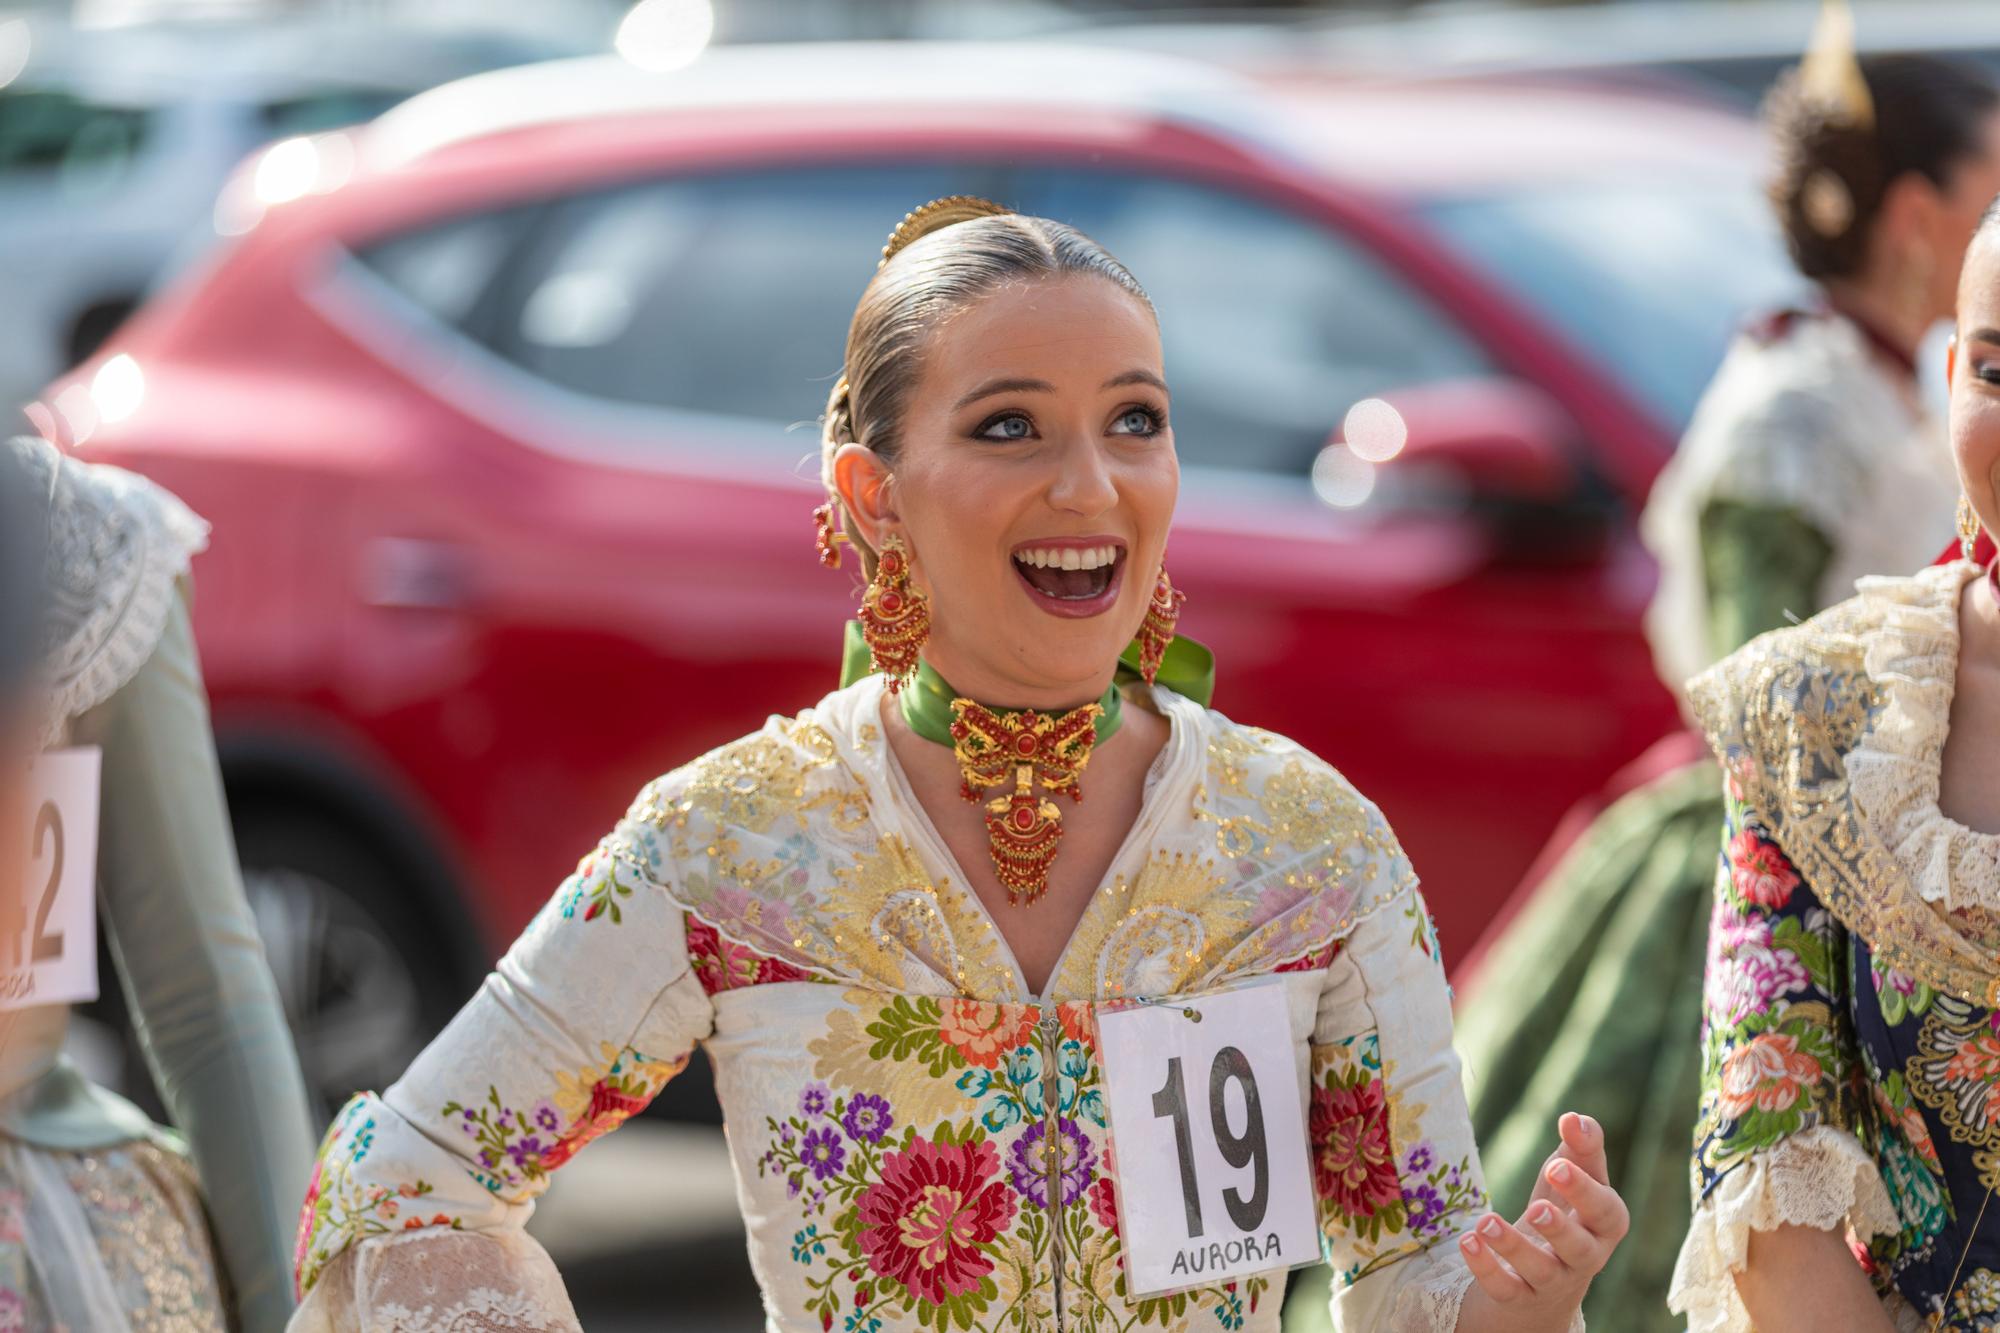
[236,811,464,1119]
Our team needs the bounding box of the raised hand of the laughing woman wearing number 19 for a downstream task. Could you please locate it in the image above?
[1458,1113,1630,1333]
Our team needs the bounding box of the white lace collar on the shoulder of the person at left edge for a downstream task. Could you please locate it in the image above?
[0,436,208,749]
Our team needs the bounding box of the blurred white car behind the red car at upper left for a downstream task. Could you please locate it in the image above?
[0,18,582,410]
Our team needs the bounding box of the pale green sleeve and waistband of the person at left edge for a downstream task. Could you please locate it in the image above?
[0,602,314,1333]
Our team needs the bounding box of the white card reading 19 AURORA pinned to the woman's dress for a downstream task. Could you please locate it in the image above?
[1098,983,1320,1295]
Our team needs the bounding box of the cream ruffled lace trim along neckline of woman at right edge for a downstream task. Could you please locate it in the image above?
[1846,562,2000,911]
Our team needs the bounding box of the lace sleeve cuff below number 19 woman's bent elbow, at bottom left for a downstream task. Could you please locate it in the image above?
[286,1231,582,1333]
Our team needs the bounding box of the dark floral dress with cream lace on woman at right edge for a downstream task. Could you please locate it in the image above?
[1672,562,2000,1333]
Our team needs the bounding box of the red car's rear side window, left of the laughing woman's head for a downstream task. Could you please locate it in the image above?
[478,164,988,424]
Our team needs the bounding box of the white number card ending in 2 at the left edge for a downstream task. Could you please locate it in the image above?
[0,749,102,1009]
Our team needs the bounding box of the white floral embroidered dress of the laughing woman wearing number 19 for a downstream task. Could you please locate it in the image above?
[294,677,1484,1333]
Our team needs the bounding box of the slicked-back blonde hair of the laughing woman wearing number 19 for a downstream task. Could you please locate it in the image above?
[820,194,1152,578]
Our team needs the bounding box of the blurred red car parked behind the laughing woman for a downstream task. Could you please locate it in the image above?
[40,44,1788,1095]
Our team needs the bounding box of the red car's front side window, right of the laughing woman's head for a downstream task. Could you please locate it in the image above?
[1010,168,1490,474]
